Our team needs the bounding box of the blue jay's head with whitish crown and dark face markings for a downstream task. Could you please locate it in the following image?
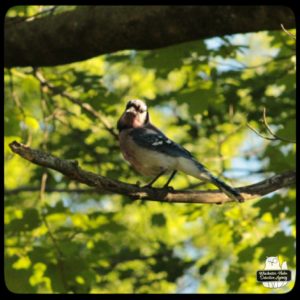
[118,99,149,131]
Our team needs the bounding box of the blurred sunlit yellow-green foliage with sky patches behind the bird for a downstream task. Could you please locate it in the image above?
[4,6,296,293]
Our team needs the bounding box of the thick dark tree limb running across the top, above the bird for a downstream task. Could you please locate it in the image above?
[4,6,295,67]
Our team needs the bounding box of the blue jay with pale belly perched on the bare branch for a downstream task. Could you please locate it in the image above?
[117,100,244,202]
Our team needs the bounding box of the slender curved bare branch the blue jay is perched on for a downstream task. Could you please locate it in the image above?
[9,141,296,204]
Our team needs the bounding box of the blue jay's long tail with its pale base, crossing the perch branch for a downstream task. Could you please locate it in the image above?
[178,158,244,202]
